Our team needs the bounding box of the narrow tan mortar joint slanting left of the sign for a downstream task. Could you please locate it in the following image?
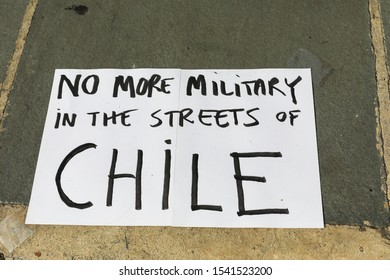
[0,0,38,132]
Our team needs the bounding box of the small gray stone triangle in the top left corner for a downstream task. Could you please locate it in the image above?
[0,0,28,83]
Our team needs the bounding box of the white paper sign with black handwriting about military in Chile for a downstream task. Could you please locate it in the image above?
[26,69,323,227]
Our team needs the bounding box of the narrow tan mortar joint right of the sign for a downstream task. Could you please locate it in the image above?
[369,0,390,207]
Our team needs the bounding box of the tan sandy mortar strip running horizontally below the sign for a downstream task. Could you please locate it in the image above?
[0,205,390,260]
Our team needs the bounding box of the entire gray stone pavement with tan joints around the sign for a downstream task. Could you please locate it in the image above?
[0,0,390,259]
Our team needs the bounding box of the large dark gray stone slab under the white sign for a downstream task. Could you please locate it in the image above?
[0,0,389,226]
